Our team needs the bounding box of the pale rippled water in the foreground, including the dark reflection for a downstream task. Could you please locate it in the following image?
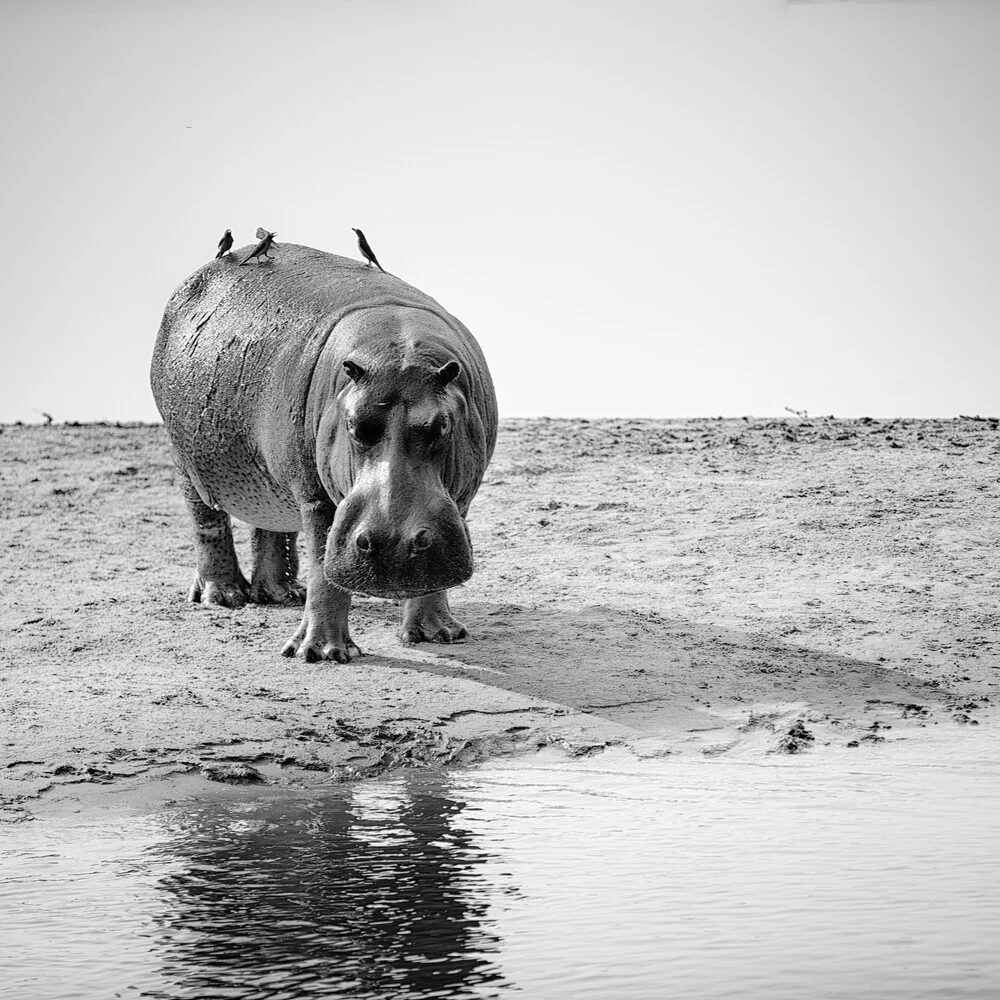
[0,729,1000,1000]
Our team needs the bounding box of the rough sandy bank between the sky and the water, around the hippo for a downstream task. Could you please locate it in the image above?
[0,418,1000,819]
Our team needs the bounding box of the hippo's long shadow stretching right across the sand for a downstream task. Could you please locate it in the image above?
[358,602,949,732]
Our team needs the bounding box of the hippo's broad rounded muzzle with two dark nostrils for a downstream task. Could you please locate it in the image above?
[323,462,473,599]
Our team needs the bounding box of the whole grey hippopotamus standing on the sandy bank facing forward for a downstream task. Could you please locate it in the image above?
[150,243,497,663]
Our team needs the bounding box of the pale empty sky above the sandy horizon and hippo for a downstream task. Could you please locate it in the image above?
[0,0,1000,422]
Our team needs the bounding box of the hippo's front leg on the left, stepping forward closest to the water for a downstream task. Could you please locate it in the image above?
[281,500,361,663]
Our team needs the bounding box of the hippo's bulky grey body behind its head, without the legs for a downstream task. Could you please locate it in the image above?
[150,243,497,530]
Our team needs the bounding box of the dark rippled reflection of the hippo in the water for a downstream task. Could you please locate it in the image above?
[147,779,498,998]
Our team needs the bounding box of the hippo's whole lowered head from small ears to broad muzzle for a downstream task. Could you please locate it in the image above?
[323,359,478,598]
